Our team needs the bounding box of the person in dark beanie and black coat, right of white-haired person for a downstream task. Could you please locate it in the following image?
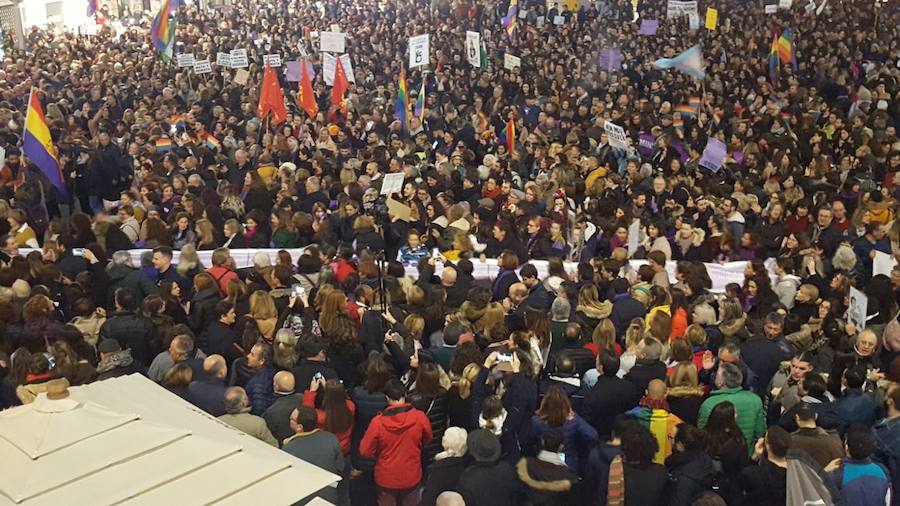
[456,429,521,506]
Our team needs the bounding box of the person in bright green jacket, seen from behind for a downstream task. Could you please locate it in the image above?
[697,362,766,455]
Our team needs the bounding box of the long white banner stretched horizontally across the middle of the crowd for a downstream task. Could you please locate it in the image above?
[42,248,772,292]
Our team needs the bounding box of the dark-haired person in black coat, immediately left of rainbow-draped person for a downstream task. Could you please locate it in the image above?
[581,350,643,440]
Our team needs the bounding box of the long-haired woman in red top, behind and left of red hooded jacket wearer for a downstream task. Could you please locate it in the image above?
[303,377,356,456]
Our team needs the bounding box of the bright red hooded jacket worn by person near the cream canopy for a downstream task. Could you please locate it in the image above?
[359,403,432,489]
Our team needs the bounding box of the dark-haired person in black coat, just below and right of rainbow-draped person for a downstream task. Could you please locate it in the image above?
[666,423,716,506]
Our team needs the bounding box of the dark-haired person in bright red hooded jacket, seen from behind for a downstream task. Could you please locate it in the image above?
[359,379,432,506]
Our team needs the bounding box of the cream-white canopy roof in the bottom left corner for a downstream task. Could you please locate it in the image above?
[0,374,339,506]
